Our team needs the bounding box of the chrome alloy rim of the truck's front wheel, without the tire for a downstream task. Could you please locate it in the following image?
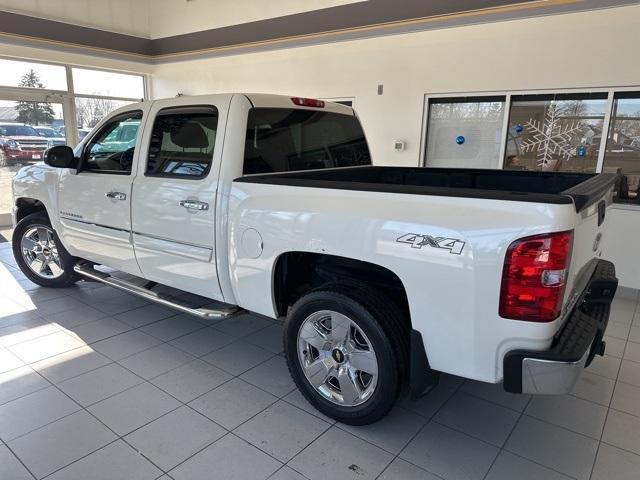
[20,225,64,279]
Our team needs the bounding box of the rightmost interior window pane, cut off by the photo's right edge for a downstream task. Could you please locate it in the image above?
[603,92,640,203]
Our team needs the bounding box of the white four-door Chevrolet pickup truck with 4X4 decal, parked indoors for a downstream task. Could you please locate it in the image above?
[13,94,617,424]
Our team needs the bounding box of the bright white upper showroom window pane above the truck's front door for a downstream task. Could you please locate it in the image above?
[72,68,144,99]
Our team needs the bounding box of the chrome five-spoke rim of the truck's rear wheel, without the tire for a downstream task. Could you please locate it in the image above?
[298,310,378,407]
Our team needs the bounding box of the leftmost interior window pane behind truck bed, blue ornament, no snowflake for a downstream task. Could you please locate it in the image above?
[425,97,505,168]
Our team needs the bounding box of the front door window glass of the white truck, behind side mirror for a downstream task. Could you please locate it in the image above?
[82,112,142,174]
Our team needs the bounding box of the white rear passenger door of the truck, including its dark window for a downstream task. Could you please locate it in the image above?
[132,96,231,300]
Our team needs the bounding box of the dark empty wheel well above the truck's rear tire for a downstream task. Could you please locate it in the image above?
[273,252,411,329]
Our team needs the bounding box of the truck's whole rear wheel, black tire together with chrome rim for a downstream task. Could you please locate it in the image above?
[284,285,409,425]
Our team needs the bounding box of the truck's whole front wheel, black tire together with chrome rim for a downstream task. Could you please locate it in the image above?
[11,212,80,288]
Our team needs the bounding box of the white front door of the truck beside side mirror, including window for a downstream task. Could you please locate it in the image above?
[58,110,144,275]
